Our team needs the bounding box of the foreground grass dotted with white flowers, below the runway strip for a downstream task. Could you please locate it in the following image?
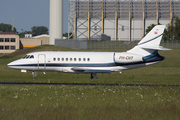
[0,85,180,120]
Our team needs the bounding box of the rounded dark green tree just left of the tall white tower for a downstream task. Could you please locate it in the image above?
[31,26,49,36]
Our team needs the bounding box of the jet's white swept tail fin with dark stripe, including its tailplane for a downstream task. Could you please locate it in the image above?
[127,25,170,56]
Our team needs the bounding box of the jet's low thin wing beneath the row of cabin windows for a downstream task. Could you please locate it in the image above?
[72,68,111,73]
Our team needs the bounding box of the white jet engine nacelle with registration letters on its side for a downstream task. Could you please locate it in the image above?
[114,52,143,63]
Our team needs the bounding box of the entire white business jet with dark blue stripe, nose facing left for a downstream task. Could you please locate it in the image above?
[7,25,170,79]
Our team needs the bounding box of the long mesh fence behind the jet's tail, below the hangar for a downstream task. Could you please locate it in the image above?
[87,40,180,49]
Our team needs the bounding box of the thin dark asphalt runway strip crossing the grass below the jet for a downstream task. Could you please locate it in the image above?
[0,82,180,87]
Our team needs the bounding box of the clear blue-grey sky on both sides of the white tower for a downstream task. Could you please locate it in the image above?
[0,0,68,33]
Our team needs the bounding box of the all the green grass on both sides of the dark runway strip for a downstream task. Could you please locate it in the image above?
[0,46,180,120]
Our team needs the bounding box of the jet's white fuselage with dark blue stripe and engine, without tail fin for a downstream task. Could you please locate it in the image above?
[8,51,162,73]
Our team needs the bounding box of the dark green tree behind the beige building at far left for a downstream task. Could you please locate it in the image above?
[0,23,17,33]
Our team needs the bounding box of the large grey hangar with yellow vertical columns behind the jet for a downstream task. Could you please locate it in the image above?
[68,0,180,41]
